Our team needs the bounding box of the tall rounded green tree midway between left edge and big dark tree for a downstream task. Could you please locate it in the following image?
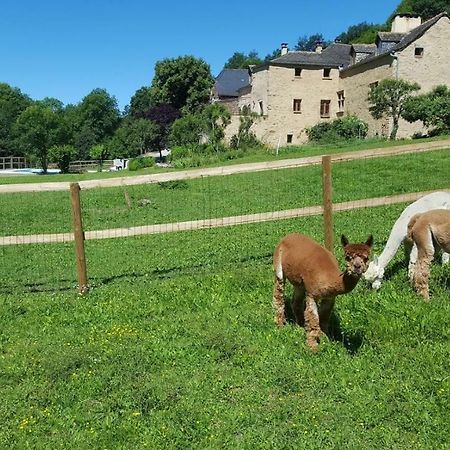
[74,89,120,159]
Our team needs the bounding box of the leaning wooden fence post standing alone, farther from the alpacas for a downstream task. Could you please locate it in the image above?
[70,183,89,295]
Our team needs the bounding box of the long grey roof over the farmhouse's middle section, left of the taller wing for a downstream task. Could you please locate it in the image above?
[269,43,351,67]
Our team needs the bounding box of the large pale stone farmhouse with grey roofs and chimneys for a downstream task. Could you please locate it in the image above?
[215,13,450,146]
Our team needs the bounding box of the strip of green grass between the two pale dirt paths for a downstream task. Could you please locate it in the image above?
[0,150,450,236]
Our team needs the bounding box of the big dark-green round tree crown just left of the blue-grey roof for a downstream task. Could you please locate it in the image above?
[151,56,214,113]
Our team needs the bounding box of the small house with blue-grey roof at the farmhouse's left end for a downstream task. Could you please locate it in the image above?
[211,69,250,114]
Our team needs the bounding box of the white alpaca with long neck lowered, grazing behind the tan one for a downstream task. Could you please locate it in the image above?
[363,192,450,289]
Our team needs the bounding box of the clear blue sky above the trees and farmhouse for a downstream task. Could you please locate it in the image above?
[0,0,400,109]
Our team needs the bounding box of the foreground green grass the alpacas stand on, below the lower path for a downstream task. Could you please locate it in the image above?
[0,205,450,450]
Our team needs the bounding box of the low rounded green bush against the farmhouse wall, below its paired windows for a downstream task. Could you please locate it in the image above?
[306,116,369,143]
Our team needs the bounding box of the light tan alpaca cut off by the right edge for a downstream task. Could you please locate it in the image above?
[407,209,450,300]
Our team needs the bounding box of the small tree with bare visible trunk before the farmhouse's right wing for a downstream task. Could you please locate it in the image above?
[368,79,420,140]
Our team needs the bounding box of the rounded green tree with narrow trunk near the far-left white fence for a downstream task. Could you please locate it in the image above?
[14,104,65,172]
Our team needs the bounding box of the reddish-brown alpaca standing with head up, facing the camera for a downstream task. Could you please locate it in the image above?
[273,233,373,351]
